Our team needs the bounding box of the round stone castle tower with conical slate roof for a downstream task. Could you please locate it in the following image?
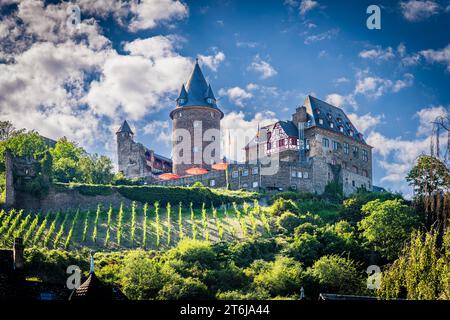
[170,60,223,176]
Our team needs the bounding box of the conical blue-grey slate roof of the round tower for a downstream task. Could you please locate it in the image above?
[177,60,220,115]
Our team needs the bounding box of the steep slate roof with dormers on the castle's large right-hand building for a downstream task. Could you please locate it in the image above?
[303,95,366,144]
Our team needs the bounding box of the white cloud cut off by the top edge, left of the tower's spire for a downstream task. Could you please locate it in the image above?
[129,0,189,31]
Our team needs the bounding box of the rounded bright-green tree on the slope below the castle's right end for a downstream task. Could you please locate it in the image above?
[358,199,421,259]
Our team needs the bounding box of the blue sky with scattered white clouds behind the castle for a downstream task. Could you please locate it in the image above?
[0,0,450,194]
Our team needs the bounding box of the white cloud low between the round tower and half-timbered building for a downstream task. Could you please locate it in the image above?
[221,111,278,161]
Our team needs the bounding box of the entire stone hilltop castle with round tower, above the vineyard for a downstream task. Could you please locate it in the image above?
[116,62,373,195]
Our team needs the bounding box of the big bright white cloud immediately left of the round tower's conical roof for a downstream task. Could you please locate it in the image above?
[84,36,192,120]
